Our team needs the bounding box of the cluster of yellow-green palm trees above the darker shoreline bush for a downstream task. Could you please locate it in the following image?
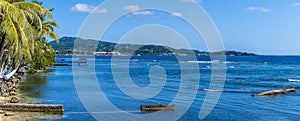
[0,0,56,80]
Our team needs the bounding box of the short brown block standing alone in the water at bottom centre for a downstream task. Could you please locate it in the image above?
[141,104,175,112]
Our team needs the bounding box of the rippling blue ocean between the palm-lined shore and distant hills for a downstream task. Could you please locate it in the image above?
[20,56,300,121]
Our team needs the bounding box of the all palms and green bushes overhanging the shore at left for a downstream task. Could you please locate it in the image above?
[0,0,59,80]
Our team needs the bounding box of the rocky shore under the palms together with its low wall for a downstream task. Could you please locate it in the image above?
[0,67,63,121]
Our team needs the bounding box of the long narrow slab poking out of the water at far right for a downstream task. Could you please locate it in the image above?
[251,88,296,96]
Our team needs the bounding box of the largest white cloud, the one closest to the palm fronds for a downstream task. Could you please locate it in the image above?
[71,3,108,13]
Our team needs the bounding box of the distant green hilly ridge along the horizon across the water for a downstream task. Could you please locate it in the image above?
[49,37,256,56]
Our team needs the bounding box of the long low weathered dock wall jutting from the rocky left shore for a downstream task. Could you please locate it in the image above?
[0,103,64,113]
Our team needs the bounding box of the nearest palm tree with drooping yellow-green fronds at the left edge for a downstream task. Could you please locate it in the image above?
[0,0,26,78]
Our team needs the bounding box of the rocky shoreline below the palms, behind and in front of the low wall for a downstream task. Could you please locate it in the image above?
[0,68,63,121]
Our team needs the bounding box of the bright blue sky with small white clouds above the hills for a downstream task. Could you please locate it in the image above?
[41,0,300,55]
